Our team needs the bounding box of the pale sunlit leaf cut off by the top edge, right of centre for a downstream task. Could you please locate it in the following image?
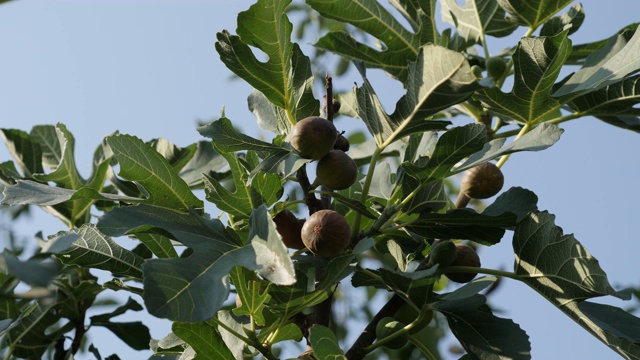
[441,0,518,43]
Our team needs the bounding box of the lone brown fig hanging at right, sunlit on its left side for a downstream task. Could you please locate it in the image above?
[460,162,504,199]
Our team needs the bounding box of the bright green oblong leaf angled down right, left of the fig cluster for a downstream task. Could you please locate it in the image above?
[107,135,204,212]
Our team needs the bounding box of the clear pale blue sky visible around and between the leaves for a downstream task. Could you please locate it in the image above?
[0,0,640,359]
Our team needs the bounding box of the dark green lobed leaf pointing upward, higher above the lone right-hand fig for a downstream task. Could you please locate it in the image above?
[477,30,571,124]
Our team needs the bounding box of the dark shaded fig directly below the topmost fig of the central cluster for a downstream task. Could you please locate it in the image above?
[316,150,358,190]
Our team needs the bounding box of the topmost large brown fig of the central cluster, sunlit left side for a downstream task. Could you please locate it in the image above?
[290,116,338,160]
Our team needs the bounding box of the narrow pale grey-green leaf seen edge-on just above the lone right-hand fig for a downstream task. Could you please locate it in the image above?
[453,123,564,172]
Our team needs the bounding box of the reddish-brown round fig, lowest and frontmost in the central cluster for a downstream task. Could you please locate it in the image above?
[301,210,351,257]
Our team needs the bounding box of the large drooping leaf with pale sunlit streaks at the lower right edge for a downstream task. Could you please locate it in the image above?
[513,212,640,359]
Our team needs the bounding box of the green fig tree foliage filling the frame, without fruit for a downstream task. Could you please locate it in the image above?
[0,0,640,359]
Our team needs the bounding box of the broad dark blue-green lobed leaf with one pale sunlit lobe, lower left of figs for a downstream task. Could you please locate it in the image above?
[98,205,295,322]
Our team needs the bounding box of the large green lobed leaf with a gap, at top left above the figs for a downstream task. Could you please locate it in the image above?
[216,0,319,127]
